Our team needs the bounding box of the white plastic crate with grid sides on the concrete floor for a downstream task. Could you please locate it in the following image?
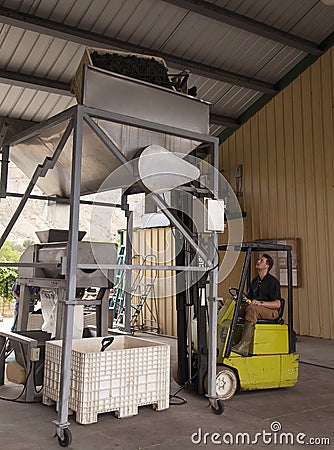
[43,336,170,424]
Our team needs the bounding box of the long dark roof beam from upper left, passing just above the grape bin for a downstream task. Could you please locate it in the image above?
[0,7,277,95]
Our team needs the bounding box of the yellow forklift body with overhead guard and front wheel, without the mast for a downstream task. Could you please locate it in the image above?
[206,242,299,402]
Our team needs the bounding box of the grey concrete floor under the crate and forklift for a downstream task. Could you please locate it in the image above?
[0,328,334,450]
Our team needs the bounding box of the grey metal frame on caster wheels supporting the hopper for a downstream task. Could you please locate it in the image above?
[0,105,219,441]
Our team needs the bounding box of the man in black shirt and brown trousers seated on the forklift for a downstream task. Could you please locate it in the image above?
[232,253,281,356]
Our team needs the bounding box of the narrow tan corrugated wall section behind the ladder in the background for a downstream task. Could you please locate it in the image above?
[132,227,176,336]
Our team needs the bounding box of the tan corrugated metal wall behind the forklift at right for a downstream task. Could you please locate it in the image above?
[221,49,334,339]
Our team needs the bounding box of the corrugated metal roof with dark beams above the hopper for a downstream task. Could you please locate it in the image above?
[0,0,334,138]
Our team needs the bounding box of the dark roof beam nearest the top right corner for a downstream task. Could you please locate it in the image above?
[163,0,322,56]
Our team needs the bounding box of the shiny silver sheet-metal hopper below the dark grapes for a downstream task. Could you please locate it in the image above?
[10,66,209,197]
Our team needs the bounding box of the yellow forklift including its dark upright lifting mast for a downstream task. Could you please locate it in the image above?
[177,242,299,414]
